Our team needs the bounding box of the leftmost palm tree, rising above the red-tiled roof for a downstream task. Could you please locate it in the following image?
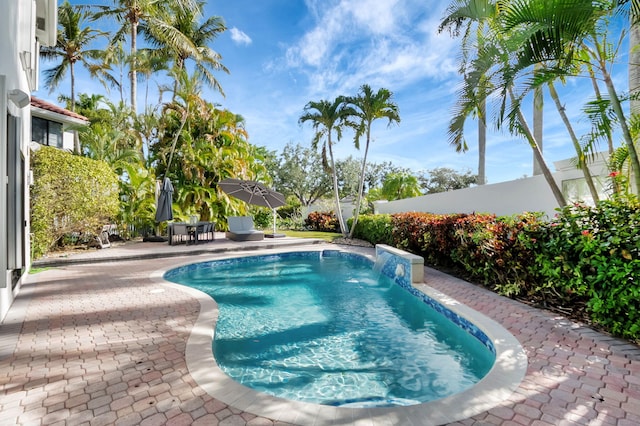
[40,1,115,111]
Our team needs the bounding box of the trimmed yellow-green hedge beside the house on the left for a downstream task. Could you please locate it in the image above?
[31,146,119,258]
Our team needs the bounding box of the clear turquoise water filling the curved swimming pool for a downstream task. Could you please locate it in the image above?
[165,252,495,406]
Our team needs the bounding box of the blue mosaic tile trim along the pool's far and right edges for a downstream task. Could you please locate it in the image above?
[163,250,496,355]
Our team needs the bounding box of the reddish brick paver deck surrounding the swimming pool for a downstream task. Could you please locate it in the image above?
[0,238,640,426]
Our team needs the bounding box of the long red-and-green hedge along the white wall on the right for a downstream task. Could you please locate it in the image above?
[354,201,640,340]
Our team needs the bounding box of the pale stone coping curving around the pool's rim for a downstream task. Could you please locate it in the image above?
[150,247,528,426]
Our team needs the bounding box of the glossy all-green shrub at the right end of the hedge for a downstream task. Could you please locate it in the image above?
[531,201,640,339]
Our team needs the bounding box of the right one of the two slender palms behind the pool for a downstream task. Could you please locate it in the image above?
[348,84,400,238]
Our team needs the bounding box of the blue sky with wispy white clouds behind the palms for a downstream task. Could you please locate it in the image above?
[35,0,626,183]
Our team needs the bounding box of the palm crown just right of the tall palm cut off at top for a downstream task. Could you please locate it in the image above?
[145,2,229,96]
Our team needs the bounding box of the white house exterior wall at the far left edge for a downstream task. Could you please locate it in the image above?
[0,0,57,321]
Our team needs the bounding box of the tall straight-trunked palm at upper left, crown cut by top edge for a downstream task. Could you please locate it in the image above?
[93,0,198,113]
